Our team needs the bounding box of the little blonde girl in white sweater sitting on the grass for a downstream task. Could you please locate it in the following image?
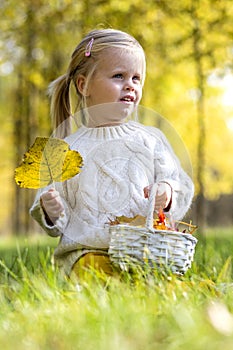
[30,29,193,276]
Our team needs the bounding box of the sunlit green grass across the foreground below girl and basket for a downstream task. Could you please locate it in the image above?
[0,229,233,350]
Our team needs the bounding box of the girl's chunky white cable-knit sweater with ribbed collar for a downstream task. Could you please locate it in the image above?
[30,121,193,274]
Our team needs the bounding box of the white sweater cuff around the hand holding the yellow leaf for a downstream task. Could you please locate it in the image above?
[29,187,68,237]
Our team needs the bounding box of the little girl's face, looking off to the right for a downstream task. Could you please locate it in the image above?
[81,48,143,125]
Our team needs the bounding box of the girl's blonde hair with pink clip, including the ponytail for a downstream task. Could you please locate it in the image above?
[49,29,146,137]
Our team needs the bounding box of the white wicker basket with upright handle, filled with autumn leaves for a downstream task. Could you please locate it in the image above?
[109,185,197,275]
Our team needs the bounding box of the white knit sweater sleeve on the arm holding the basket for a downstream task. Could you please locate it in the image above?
[150,129,194,220]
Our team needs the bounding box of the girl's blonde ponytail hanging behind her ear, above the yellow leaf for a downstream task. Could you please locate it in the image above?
[48,74,71,138]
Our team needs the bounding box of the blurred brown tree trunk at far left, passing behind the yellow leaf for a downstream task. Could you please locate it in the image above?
[12,4,38,234]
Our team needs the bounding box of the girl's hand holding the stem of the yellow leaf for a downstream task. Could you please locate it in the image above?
[40,188,64,223]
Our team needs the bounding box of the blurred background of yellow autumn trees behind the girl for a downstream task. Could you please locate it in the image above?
[0,0,233,235]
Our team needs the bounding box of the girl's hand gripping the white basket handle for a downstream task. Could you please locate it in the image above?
[144,182,172,211]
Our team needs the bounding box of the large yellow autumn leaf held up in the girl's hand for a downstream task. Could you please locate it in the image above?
[15,137,83,189]
